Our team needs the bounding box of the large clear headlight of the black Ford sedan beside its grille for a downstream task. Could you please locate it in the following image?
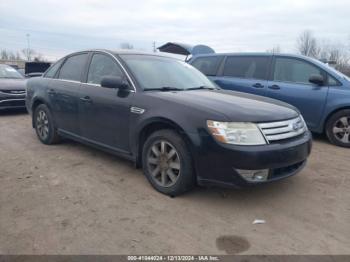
[207,120,266,145]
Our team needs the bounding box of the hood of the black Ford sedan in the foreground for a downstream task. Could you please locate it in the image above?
[152,90,299,123]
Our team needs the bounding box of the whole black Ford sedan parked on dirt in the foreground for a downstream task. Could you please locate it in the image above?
[26,50,311,195]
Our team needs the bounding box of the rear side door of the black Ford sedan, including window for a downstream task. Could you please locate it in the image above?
[47,53,88,135]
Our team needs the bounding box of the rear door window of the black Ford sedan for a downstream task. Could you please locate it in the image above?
[58,54,88,81]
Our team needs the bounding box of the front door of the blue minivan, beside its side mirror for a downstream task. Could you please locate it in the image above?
[267,56,328,129]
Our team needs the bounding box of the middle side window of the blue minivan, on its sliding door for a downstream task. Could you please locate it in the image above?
[224,56,269,79]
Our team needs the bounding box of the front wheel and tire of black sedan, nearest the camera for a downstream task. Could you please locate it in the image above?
[142,129,195,196]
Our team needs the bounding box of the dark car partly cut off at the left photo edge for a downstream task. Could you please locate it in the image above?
[0,64,26,110]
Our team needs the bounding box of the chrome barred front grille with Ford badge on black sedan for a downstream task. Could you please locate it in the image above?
[258,116,306,142]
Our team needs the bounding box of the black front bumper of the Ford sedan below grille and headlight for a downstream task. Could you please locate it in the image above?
[195,131,312,187]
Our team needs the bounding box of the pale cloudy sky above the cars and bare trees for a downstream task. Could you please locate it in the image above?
[0,0,350,60]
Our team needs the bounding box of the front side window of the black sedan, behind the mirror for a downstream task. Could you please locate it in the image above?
[87,54,123,85]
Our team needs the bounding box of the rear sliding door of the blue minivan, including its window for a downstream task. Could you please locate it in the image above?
[213,55,271,96]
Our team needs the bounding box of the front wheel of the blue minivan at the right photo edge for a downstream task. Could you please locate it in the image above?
[326,109,350,148]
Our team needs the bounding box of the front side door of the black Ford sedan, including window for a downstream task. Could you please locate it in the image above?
[79,52,134,153]
